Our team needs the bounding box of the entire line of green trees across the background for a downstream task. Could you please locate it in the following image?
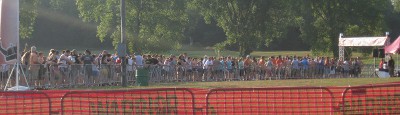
[20,0,400,57]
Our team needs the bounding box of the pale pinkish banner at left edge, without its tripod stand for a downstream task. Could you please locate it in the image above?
[0,0,19,64]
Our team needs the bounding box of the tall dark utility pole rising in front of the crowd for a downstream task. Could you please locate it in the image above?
[119,0,128,87]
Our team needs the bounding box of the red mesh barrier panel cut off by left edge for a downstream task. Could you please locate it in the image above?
[0,91,52,115]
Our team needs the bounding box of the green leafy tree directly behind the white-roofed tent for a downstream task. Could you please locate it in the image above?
[298,0,391,57]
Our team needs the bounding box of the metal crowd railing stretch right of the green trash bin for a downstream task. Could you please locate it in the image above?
[145,65,377,82]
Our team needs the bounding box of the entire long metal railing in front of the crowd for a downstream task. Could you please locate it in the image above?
[0,64,386,89]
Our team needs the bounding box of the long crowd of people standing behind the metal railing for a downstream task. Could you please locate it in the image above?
[7,46,370,86]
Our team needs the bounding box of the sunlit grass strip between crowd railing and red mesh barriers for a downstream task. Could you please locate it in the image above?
[85,77,400,89]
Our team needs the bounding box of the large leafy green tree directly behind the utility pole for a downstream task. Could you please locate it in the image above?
[76,0,188,52]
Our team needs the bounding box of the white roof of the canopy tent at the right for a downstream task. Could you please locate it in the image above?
[339,36,390,46]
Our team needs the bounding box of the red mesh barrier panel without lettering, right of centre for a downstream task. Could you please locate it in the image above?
[206,87,334,115]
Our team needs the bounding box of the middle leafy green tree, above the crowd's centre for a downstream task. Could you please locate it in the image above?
[191,0,293,56]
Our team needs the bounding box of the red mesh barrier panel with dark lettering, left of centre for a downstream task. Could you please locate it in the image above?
[61,88,195,115]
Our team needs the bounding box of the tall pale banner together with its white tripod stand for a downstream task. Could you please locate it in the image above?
[4,0,29,91]
